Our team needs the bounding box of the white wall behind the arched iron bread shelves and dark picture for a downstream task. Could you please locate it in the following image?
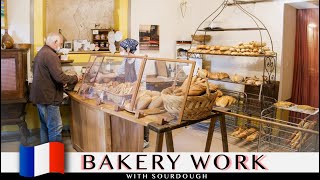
[130,0,284,95]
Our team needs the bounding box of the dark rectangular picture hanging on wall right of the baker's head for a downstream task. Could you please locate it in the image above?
[139,25,160,51]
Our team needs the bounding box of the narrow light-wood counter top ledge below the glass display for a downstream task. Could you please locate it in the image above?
[67,92,165,126]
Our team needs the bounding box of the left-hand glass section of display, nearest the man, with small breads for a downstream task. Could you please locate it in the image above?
[78,55,146,107]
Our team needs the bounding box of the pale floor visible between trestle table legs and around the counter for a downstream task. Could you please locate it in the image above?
[1,127,248,152]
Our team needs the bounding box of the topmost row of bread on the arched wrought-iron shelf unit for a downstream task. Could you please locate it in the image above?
[188,41,276,57]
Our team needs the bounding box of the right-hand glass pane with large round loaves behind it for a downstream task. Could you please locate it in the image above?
[125,58,194,120]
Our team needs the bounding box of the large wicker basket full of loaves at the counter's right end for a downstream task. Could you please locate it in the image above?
[161,87,217,120]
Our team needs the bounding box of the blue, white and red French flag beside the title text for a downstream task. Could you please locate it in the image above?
[20,142,64,177]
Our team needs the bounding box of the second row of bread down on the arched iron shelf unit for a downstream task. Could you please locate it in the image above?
[198,69,266,86]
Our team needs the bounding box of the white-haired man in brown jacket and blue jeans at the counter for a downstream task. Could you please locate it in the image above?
[30,33,81,144]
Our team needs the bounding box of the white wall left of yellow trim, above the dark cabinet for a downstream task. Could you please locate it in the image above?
[1,0,31,81]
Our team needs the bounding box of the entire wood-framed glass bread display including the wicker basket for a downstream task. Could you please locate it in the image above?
[78,55,218,123]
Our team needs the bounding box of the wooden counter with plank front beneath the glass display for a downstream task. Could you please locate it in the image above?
[68,92,158,152]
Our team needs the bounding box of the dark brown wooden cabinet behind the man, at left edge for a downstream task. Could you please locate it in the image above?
[1,49,29,145]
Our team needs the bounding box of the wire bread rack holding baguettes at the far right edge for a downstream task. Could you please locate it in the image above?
[258,106,319,152]
